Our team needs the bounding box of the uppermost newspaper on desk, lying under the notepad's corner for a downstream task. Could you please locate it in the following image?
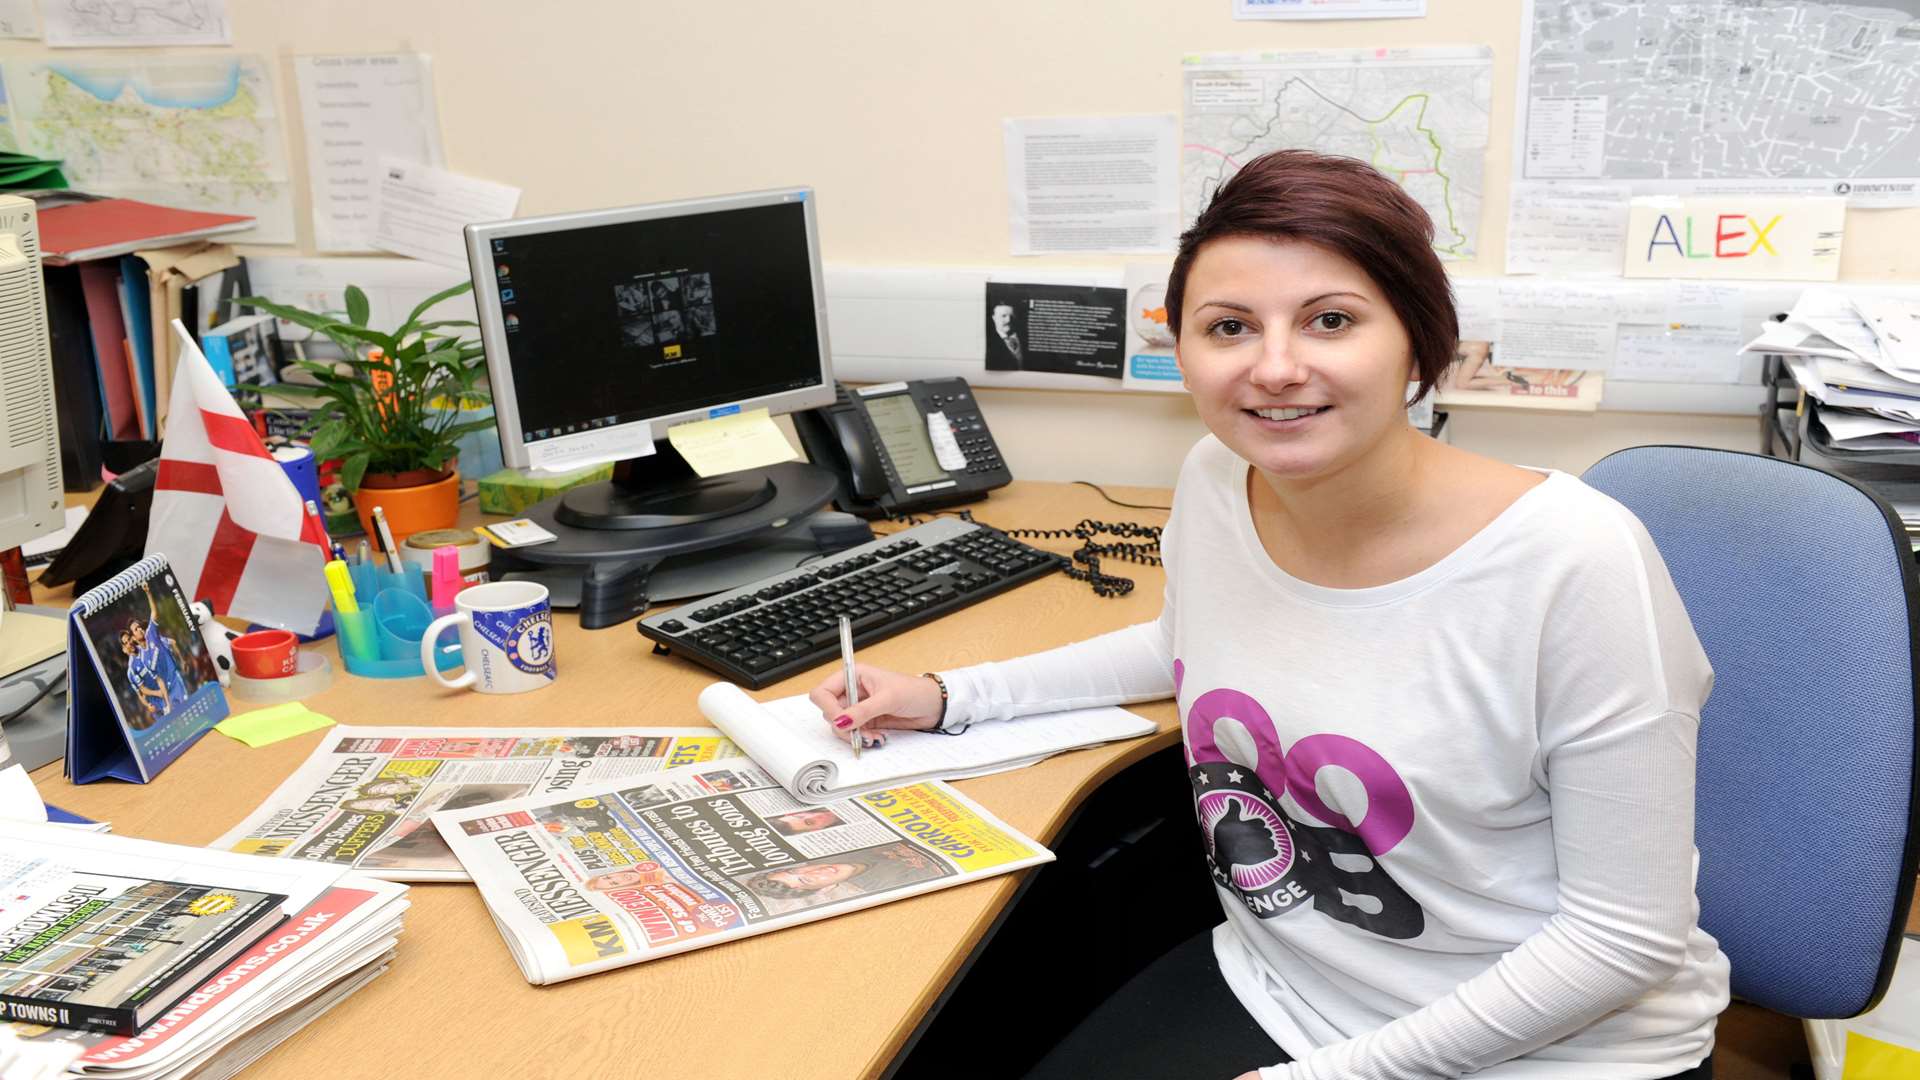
[434,757,1054,986]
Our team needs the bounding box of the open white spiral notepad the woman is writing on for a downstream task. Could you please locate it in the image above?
[699,682,1158,803]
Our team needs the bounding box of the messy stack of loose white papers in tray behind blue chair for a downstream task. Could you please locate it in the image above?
[1743,288,1920,455]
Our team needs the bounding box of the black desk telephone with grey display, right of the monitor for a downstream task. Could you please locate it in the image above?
[793,379,1014,517]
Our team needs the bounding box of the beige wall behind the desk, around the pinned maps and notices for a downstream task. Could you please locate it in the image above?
[15,0,1920,482]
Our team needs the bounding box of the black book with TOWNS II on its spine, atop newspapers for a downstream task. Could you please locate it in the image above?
[0,822,288,1036]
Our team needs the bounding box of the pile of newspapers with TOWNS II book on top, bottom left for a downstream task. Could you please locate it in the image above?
[0,821,407,1080]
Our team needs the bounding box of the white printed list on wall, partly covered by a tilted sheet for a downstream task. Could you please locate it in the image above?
[294,54,445,249]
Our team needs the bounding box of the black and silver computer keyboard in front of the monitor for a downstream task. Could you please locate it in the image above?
[639,517,1068,690]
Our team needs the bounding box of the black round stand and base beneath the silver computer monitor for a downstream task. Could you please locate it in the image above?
[492,446,847,630]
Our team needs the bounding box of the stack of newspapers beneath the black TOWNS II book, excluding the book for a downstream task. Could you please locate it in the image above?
[0,824,407,1060]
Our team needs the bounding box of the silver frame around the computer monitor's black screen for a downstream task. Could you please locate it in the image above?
[463,186,833,469]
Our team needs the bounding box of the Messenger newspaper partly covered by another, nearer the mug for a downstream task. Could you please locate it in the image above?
[213,726,739,882]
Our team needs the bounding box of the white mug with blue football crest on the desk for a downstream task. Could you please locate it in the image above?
[420,580,555,694]
